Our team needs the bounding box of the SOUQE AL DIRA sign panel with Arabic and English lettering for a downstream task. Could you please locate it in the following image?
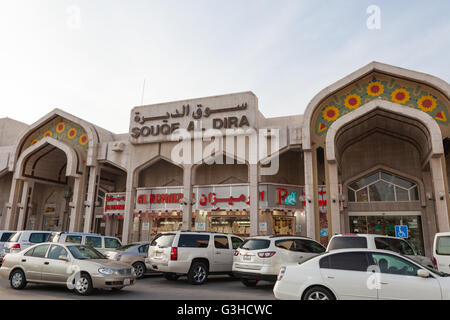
[130,92,252,142]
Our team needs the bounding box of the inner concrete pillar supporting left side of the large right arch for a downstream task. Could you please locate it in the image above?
[326,161,341,237]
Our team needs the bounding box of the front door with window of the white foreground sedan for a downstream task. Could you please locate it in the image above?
[371,252,442,300]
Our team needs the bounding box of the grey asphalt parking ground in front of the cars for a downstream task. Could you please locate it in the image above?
[0,275,275,300]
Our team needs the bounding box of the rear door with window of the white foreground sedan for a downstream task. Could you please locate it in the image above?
[319,252,378,300]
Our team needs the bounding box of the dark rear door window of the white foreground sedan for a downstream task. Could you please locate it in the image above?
[319,252,369,271]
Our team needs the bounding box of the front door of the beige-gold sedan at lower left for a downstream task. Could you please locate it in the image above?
[42,244,72,283]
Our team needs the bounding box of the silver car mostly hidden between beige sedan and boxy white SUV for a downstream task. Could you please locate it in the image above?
[105,242,151,279]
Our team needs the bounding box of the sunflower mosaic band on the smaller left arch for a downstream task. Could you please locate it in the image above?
[24,117,89,154]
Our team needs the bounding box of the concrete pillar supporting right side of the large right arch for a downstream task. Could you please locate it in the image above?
[430,156,450,232]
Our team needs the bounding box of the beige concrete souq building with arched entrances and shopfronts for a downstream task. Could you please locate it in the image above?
[0,62,450,255]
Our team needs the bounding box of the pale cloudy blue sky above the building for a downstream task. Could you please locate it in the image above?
[0,0,450,133]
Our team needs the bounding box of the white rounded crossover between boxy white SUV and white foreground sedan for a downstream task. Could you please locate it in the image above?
[233,236,325,287]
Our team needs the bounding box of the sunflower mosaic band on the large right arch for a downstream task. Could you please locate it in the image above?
[315,75,450,136]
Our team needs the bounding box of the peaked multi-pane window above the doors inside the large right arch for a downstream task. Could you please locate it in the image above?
[348,171,419,202]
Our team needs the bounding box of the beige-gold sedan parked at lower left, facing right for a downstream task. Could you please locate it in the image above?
[0,242,136,295]
